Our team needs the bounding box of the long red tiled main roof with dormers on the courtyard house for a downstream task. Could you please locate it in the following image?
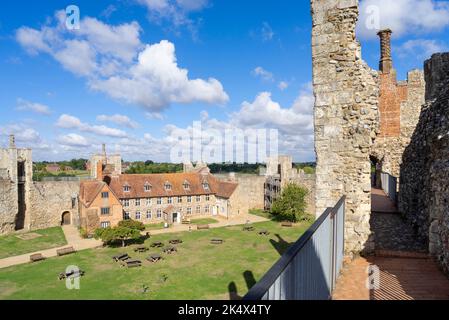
[109,173,237,199]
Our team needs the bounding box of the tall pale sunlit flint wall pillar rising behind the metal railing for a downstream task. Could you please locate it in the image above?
[312,0,379,254]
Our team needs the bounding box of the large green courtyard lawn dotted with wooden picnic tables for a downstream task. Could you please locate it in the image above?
[0,221,308,300]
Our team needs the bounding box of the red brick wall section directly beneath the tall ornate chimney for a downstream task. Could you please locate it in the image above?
[379,73,408,137]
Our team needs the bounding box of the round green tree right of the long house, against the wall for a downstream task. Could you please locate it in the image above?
[271,183,311,222]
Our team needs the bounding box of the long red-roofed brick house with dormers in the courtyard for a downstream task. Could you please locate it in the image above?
[80,163,238,232]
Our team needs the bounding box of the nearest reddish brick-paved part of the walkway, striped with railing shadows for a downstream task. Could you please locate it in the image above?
[333,257,449,300]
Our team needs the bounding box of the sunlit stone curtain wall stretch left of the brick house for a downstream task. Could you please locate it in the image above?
[28,181,80,230]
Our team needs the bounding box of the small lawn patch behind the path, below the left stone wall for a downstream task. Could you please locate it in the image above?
[0,227,67,259]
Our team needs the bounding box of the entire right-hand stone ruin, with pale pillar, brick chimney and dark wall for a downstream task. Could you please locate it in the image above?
[311,0,449,270]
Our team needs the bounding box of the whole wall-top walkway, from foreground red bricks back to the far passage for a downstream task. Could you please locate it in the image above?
[333,189,449,300]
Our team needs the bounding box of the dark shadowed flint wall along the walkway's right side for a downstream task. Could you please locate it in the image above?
[399,53,449,272]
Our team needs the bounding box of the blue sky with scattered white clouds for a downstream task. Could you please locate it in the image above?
[0,0,449,161]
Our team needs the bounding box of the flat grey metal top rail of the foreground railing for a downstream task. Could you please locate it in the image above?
[243,196,346,301]
